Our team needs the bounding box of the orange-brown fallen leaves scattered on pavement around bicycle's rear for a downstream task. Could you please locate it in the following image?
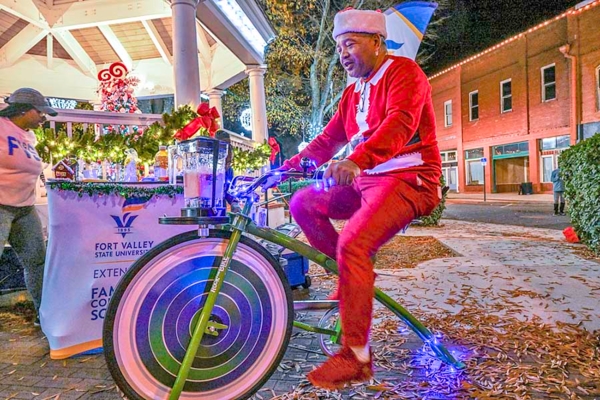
[276,230,600,400]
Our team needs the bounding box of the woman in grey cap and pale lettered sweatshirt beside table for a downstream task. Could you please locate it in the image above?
[0,88,57,318]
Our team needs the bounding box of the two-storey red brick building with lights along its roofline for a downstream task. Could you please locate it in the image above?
[430,0,600,193]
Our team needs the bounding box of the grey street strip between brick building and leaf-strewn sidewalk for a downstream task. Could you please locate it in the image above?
[444,202,570,230]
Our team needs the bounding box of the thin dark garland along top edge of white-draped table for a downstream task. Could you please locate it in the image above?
[47,181,183,199]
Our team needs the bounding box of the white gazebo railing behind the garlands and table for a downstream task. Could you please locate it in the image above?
[46,109,255,150]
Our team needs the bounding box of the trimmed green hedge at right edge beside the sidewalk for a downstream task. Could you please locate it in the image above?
[558,133,600,254]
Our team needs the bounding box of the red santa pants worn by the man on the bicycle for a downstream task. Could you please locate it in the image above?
[290,173,439,346]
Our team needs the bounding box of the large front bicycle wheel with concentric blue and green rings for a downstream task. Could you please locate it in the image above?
[103,231,293,400]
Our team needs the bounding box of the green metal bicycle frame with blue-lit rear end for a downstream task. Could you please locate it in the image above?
[169,192,465,400]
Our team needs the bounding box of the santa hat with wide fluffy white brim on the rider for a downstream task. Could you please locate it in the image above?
[333,7,387,39]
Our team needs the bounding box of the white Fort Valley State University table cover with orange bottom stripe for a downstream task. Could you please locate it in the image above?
[40,185,193,359]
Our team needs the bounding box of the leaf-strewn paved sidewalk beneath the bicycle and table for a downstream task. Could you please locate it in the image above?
[0,220,600,400]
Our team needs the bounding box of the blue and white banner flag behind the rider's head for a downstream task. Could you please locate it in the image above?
[384,1,438,60]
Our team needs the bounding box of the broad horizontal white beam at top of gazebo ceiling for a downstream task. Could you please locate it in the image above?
[51,0,172,30]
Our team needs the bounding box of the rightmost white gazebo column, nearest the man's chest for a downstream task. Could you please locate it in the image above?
[246,65,269,143]
